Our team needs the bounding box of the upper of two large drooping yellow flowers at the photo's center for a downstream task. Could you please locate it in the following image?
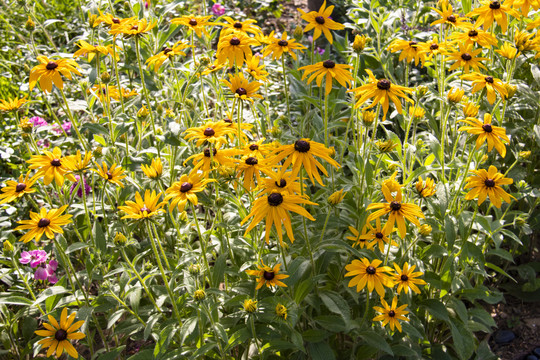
[271,139,341,186]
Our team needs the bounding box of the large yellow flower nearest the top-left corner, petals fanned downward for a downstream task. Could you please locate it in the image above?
[30,56,81,92]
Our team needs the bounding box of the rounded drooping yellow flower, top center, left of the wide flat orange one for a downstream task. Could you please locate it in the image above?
[216,33,258,67]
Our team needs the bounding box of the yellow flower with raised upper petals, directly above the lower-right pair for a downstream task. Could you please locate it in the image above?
[366,184,424,238]
